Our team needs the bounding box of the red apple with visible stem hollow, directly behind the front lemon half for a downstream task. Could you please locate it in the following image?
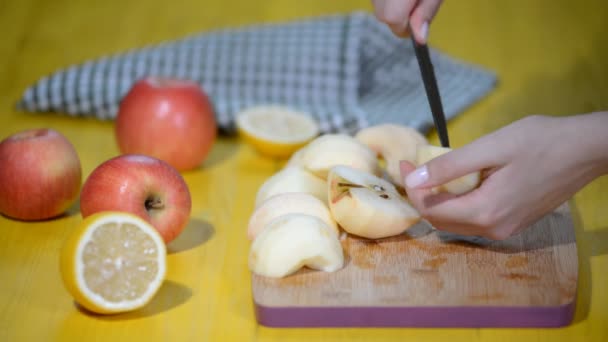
[80,154,192,243]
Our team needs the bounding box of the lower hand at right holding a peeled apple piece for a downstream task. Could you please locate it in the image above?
[402,112,608,240]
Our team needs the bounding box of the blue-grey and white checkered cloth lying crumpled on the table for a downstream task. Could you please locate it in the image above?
[18,12,496,133]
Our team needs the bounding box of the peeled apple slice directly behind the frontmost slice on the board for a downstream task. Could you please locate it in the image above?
[247,192,339,240]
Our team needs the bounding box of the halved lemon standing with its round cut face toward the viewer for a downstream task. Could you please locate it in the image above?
[60,212,167,314]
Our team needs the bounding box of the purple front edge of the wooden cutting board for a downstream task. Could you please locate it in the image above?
[254,301,576,328]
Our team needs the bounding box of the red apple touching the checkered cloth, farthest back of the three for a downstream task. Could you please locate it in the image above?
[115,78,217,171]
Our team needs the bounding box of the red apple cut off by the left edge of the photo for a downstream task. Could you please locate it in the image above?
[0,128,82,221]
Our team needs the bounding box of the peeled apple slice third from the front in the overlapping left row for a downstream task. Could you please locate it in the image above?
[255,166,327,209]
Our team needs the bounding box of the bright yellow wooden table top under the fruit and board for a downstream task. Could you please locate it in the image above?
[0,0,608,341]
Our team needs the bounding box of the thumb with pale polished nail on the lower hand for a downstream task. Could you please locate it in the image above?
[404,138,504,188]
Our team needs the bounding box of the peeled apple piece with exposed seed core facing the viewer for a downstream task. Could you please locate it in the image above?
[327,166,420,239]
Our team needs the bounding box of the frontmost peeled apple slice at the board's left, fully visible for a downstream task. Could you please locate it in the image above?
[249,214,344,278]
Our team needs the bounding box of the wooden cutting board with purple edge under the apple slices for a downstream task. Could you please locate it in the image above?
[252,205,578,327]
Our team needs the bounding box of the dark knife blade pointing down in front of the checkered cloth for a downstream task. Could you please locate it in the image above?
[410,35,450,147]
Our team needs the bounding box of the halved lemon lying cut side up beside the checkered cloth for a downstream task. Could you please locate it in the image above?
[236,106,319,158]
